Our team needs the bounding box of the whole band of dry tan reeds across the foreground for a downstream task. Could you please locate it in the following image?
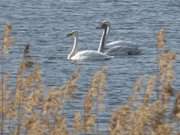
[0,24,180,135]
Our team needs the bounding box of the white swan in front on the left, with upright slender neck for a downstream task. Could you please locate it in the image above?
[67,31,112,61]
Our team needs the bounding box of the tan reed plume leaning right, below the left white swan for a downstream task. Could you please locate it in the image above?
[43,69,79,134]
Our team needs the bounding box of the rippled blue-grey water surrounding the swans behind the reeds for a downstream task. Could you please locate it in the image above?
[0,0,180,133]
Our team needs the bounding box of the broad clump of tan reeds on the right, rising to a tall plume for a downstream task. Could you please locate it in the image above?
[110,29,179,135]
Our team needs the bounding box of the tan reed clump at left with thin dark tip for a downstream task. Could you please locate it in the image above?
[15,44,38,135]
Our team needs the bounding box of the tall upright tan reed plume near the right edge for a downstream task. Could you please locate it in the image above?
[157,29,176,102]
